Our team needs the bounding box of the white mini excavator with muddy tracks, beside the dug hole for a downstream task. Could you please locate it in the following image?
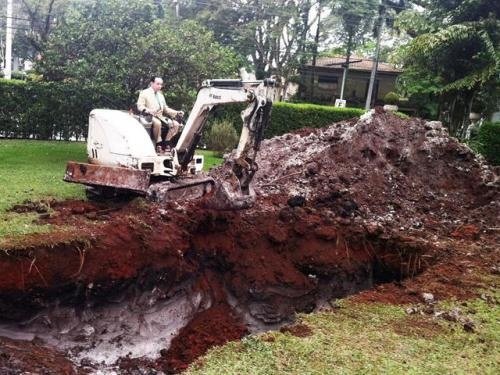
[64,79,275,210]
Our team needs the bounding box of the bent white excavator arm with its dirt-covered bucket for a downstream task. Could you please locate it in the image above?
[169,79,274,209]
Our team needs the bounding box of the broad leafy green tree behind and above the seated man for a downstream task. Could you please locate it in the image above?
[36,0,237,105]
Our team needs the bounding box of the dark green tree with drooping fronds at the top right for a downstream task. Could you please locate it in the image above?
[399,0,500,136]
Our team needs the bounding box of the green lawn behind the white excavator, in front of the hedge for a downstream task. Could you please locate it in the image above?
[0,140,221,238]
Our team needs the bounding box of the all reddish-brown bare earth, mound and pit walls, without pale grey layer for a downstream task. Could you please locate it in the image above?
[0,111,500,373]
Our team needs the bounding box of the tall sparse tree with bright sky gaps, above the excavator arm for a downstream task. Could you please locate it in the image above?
[174,0,317,97]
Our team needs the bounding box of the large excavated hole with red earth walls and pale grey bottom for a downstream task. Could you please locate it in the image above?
[0,216,422,372]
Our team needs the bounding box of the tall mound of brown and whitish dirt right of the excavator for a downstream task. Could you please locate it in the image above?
[252,110,500,236]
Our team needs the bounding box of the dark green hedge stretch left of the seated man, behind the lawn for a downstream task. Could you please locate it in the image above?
[0,79,131,140]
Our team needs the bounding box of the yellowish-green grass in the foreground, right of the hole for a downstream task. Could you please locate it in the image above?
[186,299,500,375]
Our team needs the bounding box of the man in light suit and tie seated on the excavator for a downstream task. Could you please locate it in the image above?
[137,77,184,153]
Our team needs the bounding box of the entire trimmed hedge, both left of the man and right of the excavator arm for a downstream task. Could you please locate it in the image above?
[0,79,364,139]
